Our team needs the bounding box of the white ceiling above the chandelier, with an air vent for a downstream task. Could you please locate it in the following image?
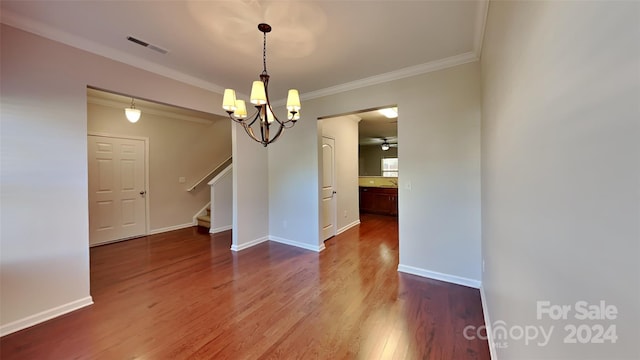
[0,0,488,145]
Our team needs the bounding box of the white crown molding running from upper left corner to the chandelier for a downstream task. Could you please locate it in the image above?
[0,10,224,94]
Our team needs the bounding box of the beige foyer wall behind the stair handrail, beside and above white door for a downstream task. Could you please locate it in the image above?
[87,94,231,233]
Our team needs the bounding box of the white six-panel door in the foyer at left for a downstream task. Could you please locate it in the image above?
[88,135,147,245]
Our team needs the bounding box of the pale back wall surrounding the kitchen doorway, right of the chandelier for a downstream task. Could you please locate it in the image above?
[269,63,480,286]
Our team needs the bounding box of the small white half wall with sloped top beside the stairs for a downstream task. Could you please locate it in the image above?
[209,165,233,233]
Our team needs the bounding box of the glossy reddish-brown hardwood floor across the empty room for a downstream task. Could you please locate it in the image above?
[0,214,490,360]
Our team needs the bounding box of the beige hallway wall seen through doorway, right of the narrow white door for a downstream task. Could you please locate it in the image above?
[320,116,360,234]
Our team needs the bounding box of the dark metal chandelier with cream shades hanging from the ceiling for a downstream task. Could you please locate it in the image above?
[222,23,300,147]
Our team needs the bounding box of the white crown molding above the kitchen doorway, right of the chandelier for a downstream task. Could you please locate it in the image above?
[300,51,478,100]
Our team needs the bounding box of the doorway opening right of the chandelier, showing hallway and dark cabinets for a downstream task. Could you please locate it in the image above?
[319,105,401,241]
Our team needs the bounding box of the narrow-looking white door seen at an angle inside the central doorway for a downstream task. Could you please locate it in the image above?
[322,136,336,241]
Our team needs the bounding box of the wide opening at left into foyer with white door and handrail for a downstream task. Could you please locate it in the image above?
[87,87,232,246]
